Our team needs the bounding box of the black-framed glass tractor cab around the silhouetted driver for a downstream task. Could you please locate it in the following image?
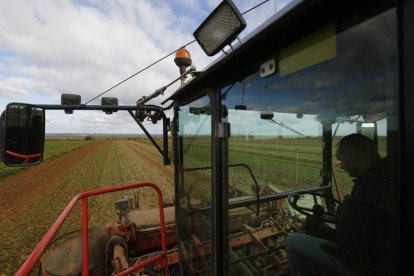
[170,1,401,275]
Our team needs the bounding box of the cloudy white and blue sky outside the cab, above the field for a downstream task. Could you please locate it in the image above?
[0,0,289,133]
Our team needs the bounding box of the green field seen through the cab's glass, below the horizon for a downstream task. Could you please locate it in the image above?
[183,136,386,197]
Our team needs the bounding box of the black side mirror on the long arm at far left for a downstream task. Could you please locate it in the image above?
[0,103,45,166]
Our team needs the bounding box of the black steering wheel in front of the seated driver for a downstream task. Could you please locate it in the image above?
[287,193,341,223]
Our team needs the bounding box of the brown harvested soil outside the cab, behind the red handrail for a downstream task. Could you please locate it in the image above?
[0,140,173,275]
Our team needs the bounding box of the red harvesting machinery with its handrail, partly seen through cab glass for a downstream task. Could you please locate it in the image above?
[21,183,300,275]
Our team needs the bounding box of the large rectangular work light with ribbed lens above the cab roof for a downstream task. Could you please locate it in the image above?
[194,0,246,56]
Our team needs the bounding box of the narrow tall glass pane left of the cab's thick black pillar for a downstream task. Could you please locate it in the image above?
[177,96,213,275]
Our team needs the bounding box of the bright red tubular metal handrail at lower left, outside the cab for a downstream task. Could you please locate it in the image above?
[16,182,169,276]
